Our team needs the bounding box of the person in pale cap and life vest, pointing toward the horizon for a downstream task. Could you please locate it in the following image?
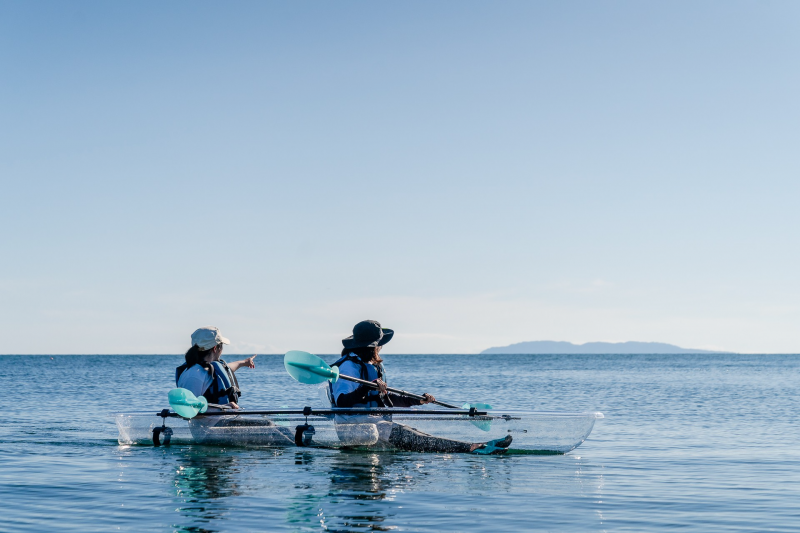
[175,326,256,409]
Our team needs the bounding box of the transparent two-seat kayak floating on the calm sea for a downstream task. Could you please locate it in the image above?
[114,407,603,454]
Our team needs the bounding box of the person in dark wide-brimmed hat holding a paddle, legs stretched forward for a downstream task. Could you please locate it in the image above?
[329,320,511,453]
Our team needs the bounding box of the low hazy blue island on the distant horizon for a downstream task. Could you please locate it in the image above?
[481,341,730,354]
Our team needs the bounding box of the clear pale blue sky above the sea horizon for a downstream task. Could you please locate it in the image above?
[0,0,800,353]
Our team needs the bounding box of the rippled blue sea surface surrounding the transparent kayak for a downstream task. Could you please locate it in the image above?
[0,353,800,533]
